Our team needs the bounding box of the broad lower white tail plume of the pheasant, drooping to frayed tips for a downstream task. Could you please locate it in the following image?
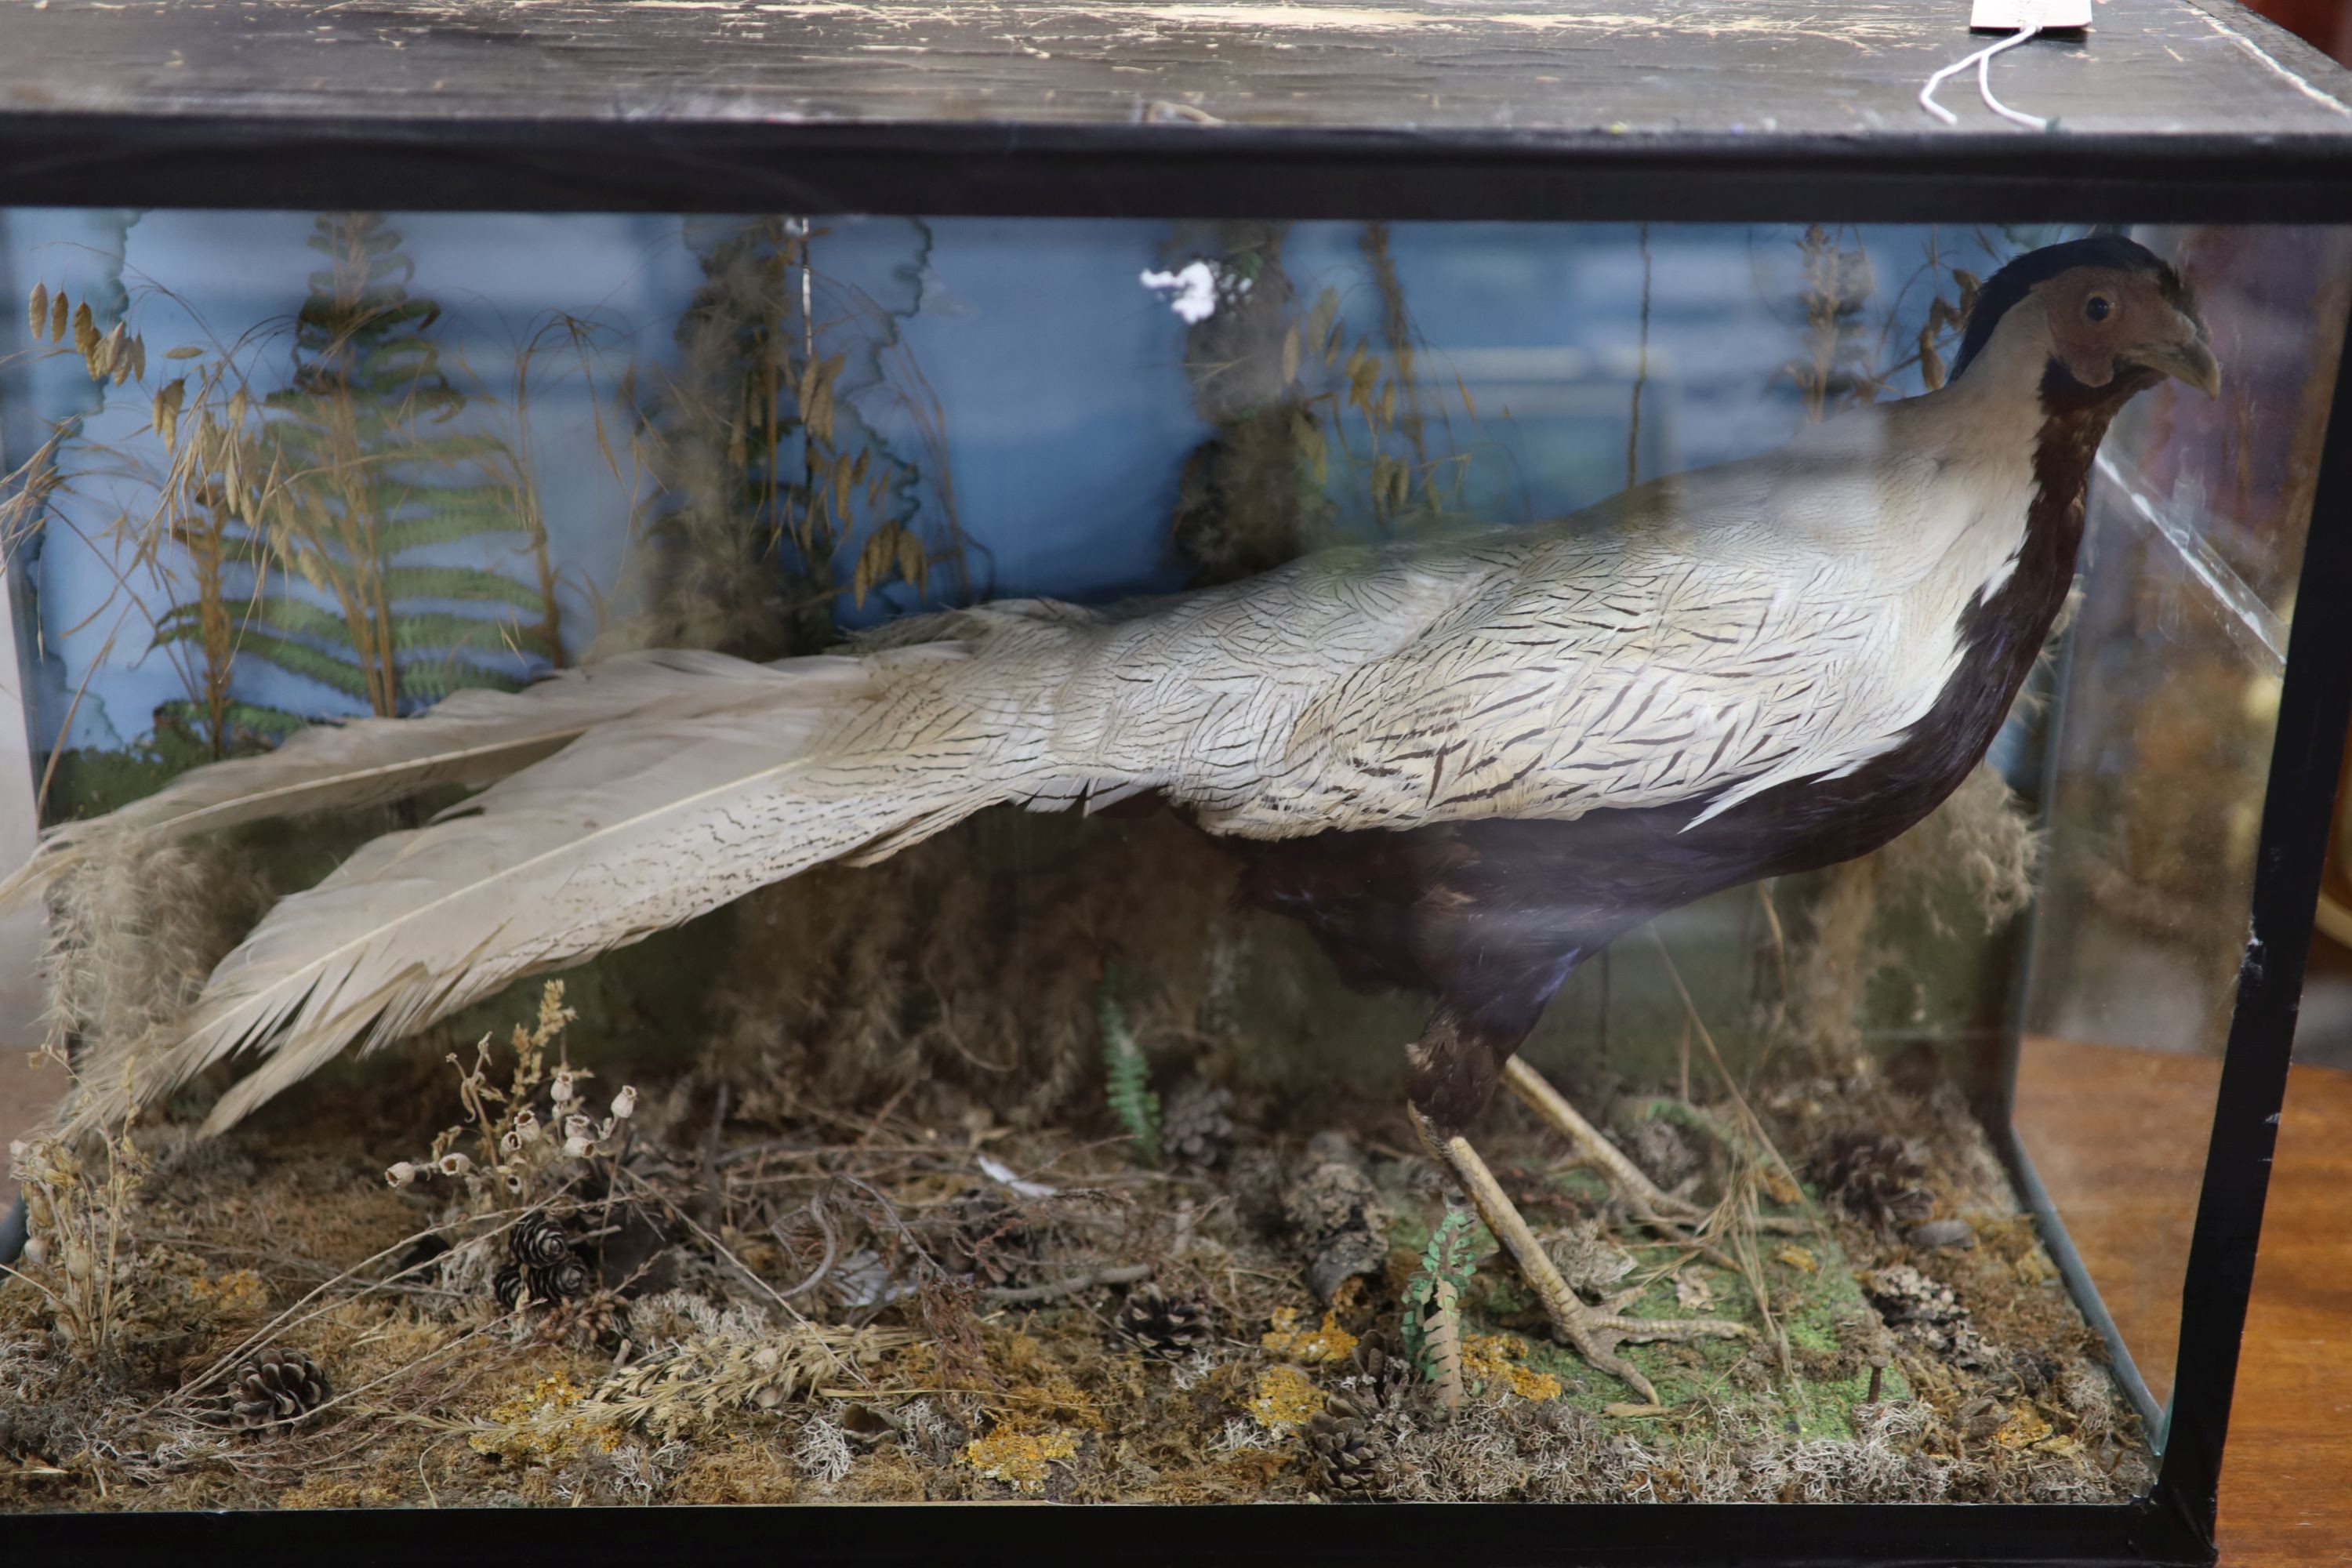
[122,644,1077,1131]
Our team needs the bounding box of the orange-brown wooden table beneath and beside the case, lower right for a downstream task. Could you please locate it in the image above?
[2018,1039,2352,1568]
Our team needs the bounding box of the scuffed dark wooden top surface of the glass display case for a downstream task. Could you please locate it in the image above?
[0,0,2352,139]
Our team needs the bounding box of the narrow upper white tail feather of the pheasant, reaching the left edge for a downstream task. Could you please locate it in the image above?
[0,649,800,909]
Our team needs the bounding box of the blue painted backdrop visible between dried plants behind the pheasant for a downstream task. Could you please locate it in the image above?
[0,209,2032,750]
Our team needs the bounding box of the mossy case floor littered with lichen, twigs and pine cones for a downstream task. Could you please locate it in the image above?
[0,926,2145,1507]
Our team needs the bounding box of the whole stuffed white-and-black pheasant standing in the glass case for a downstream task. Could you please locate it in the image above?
[0,238,2220,1396]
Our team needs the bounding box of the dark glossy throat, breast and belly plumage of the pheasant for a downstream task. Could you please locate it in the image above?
[1218,367,2154,1053]
